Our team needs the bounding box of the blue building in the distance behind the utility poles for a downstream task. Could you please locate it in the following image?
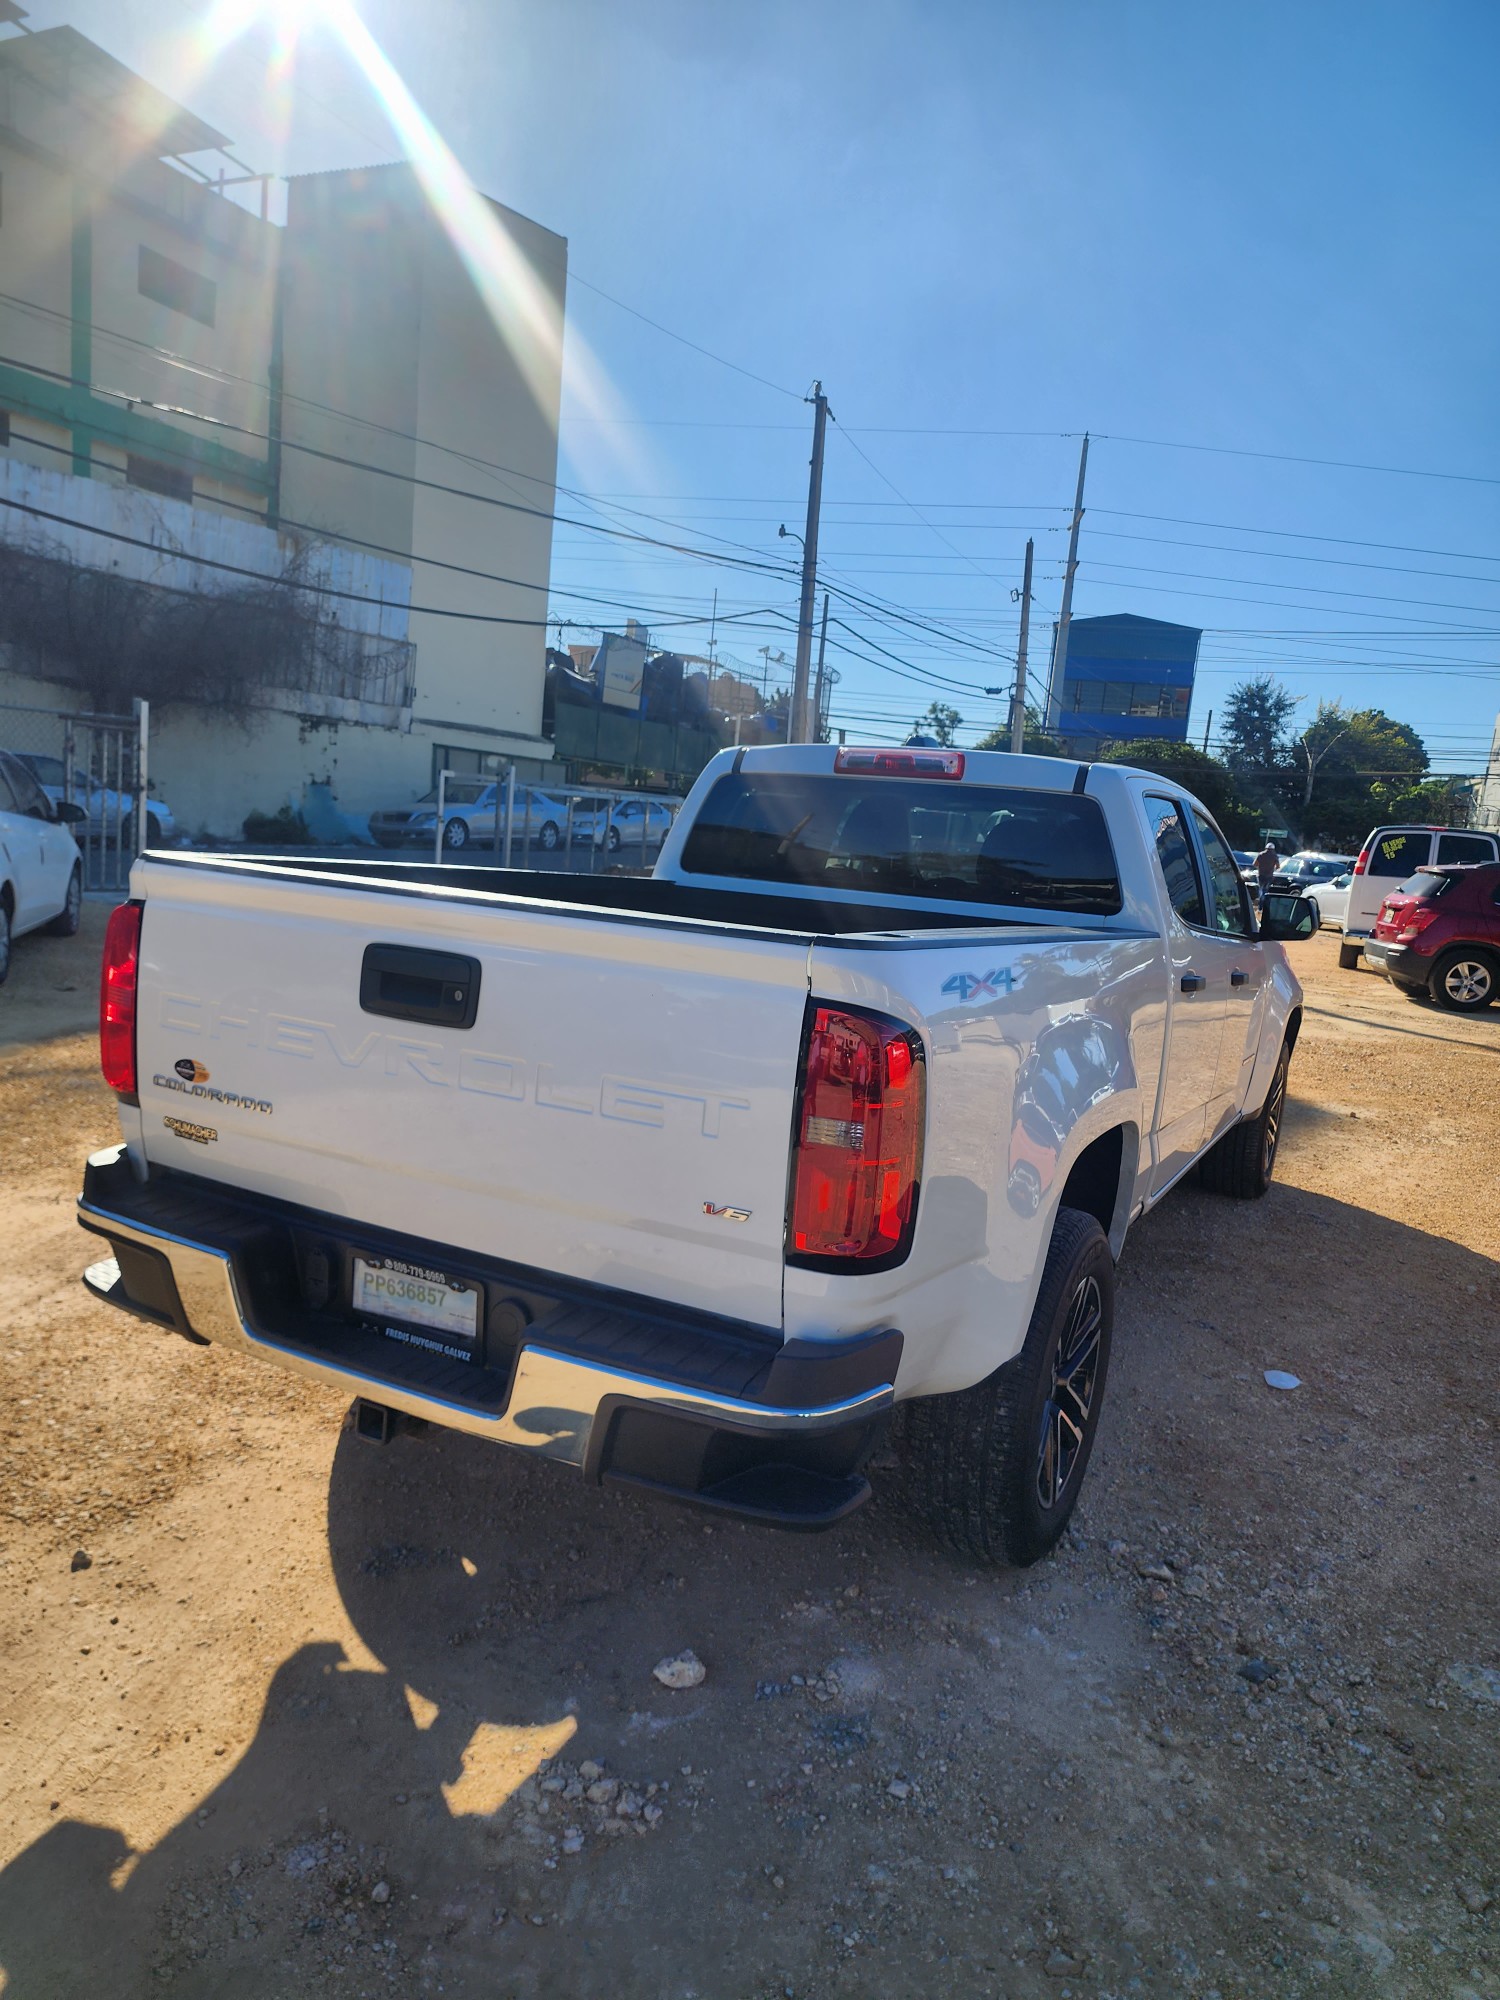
[1048,612,1202,756]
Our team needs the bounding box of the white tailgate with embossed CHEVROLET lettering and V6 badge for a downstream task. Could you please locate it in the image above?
[132,862,808,1328]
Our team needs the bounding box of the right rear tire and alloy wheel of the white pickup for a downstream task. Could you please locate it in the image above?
[900,1208,1114,1568]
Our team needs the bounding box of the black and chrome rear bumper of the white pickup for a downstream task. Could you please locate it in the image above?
[78,1146,902,1528]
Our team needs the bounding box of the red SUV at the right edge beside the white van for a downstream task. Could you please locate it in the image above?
[1364,862,1500,1014]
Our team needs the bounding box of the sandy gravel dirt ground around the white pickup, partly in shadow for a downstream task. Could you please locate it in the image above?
[0,908,1500,2000]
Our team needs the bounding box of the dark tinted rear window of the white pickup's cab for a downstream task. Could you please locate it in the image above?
[680,772,1122,916]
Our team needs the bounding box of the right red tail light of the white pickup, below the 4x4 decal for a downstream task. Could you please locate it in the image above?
[786,1006,926,1270]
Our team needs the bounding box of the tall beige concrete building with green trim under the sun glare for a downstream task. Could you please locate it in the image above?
[0,13,566,836]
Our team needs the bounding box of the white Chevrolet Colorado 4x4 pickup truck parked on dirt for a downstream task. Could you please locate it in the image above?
[78,746,1316,1562]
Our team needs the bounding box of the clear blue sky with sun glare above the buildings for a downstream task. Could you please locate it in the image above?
[28,0,1500,772]
